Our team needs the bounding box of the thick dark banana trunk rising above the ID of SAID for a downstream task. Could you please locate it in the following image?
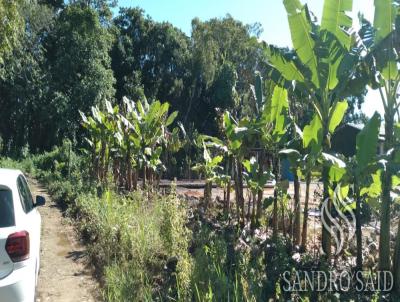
[379,114,394,271]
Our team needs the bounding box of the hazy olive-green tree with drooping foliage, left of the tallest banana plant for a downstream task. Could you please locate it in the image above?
[188,15,263,135]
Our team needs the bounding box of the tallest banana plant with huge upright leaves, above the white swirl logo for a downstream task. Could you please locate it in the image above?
[265,0,359,259]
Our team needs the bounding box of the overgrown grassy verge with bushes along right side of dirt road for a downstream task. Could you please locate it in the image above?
[0,145,192,301]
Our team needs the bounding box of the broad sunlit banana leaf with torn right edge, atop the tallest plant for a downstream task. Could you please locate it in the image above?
[321,0,353,49]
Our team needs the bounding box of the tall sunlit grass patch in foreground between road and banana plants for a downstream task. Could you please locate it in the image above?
[76,191,191,301]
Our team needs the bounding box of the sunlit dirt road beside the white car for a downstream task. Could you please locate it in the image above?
[29,179,100,302]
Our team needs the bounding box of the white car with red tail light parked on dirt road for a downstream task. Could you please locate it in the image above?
[0,169,45,302]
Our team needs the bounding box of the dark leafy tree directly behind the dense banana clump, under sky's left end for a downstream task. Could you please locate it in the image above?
[112,8,190,111]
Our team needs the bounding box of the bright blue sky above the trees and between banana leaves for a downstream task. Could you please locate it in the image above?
[118,0,382,116]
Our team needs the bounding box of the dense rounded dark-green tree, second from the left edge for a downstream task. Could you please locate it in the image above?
[46,5,115,142]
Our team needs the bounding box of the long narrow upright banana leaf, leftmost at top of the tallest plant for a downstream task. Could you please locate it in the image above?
[283,0,320,87]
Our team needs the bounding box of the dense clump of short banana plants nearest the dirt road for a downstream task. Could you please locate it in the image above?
[80,98,181,190]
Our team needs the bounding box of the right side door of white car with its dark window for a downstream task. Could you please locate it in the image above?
[17,175,41,260]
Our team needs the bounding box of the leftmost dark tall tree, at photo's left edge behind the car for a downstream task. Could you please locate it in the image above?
[0,3,57,156]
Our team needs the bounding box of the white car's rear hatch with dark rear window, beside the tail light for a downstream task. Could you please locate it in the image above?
[0,187,15,279]
